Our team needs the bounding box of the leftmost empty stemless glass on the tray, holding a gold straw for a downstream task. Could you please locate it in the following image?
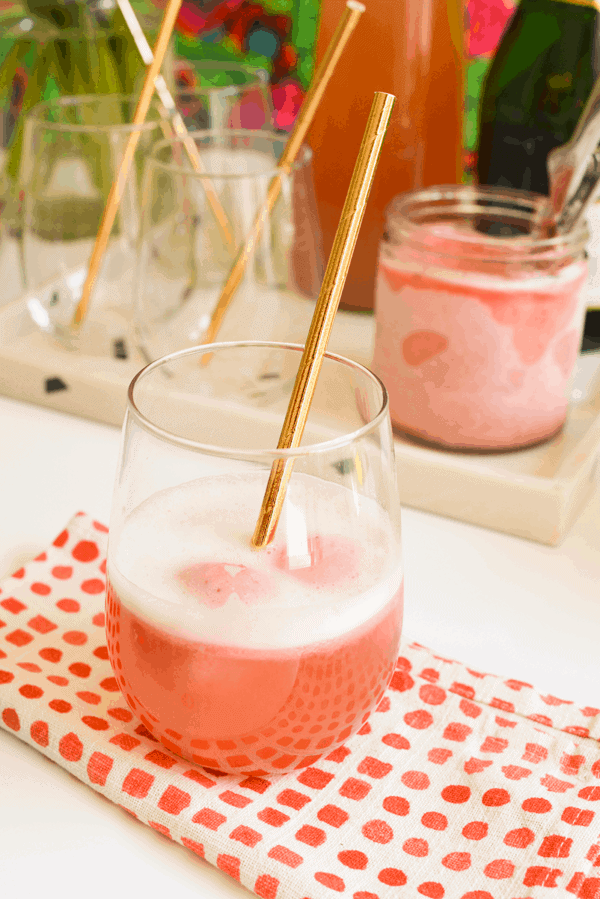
[20,94,164,358]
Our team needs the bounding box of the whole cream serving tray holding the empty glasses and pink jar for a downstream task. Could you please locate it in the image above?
[0,300,600,545]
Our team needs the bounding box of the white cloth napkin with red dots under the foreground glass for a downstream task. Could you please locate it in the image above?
[0,514,600,899]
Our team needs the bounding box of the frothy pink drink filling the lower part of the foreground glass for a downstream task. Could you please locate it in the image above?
[106,473,402,774]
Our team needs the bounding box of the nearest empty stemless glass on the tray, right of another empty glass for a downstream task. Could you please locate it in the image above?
[135,129,323,361]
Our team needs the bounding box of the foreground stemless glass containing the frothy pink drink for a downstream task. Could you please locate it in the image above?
[106,342,403,774]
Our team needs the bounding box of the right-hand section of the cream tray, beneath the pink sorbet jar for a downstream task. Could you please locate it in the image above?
[396,353,600,546]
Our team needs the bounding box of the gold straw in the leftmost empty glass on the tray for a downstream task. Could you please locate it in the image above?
[71,0,182,330]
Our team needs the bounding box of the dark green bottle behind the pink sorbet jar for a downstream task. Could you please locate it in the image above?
[477,0,599,194]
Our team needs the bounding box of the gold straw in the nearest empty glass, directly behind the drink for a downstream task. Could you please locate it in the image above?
[202,0,365,348]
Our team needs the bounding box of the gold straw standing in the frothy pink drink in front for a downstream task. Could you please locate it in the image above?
[252,92,395,549]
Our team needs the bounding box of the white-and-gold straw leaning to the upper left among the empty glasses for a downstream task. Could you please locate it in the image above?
[117,0,235,252]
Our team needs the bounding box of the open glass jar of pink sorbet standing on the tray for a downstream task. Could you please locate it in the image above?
[373,185,587,451]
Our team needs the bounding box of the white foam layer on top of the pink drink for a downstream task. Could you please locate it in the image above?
[108,471,402,649]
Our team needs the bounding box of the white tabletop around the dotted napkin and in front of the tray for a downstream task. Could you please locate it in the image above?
[0,397,600,899]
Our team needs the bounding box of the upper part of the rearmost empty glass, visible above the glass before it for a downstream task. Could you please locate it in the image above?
[176,60,273,131]
